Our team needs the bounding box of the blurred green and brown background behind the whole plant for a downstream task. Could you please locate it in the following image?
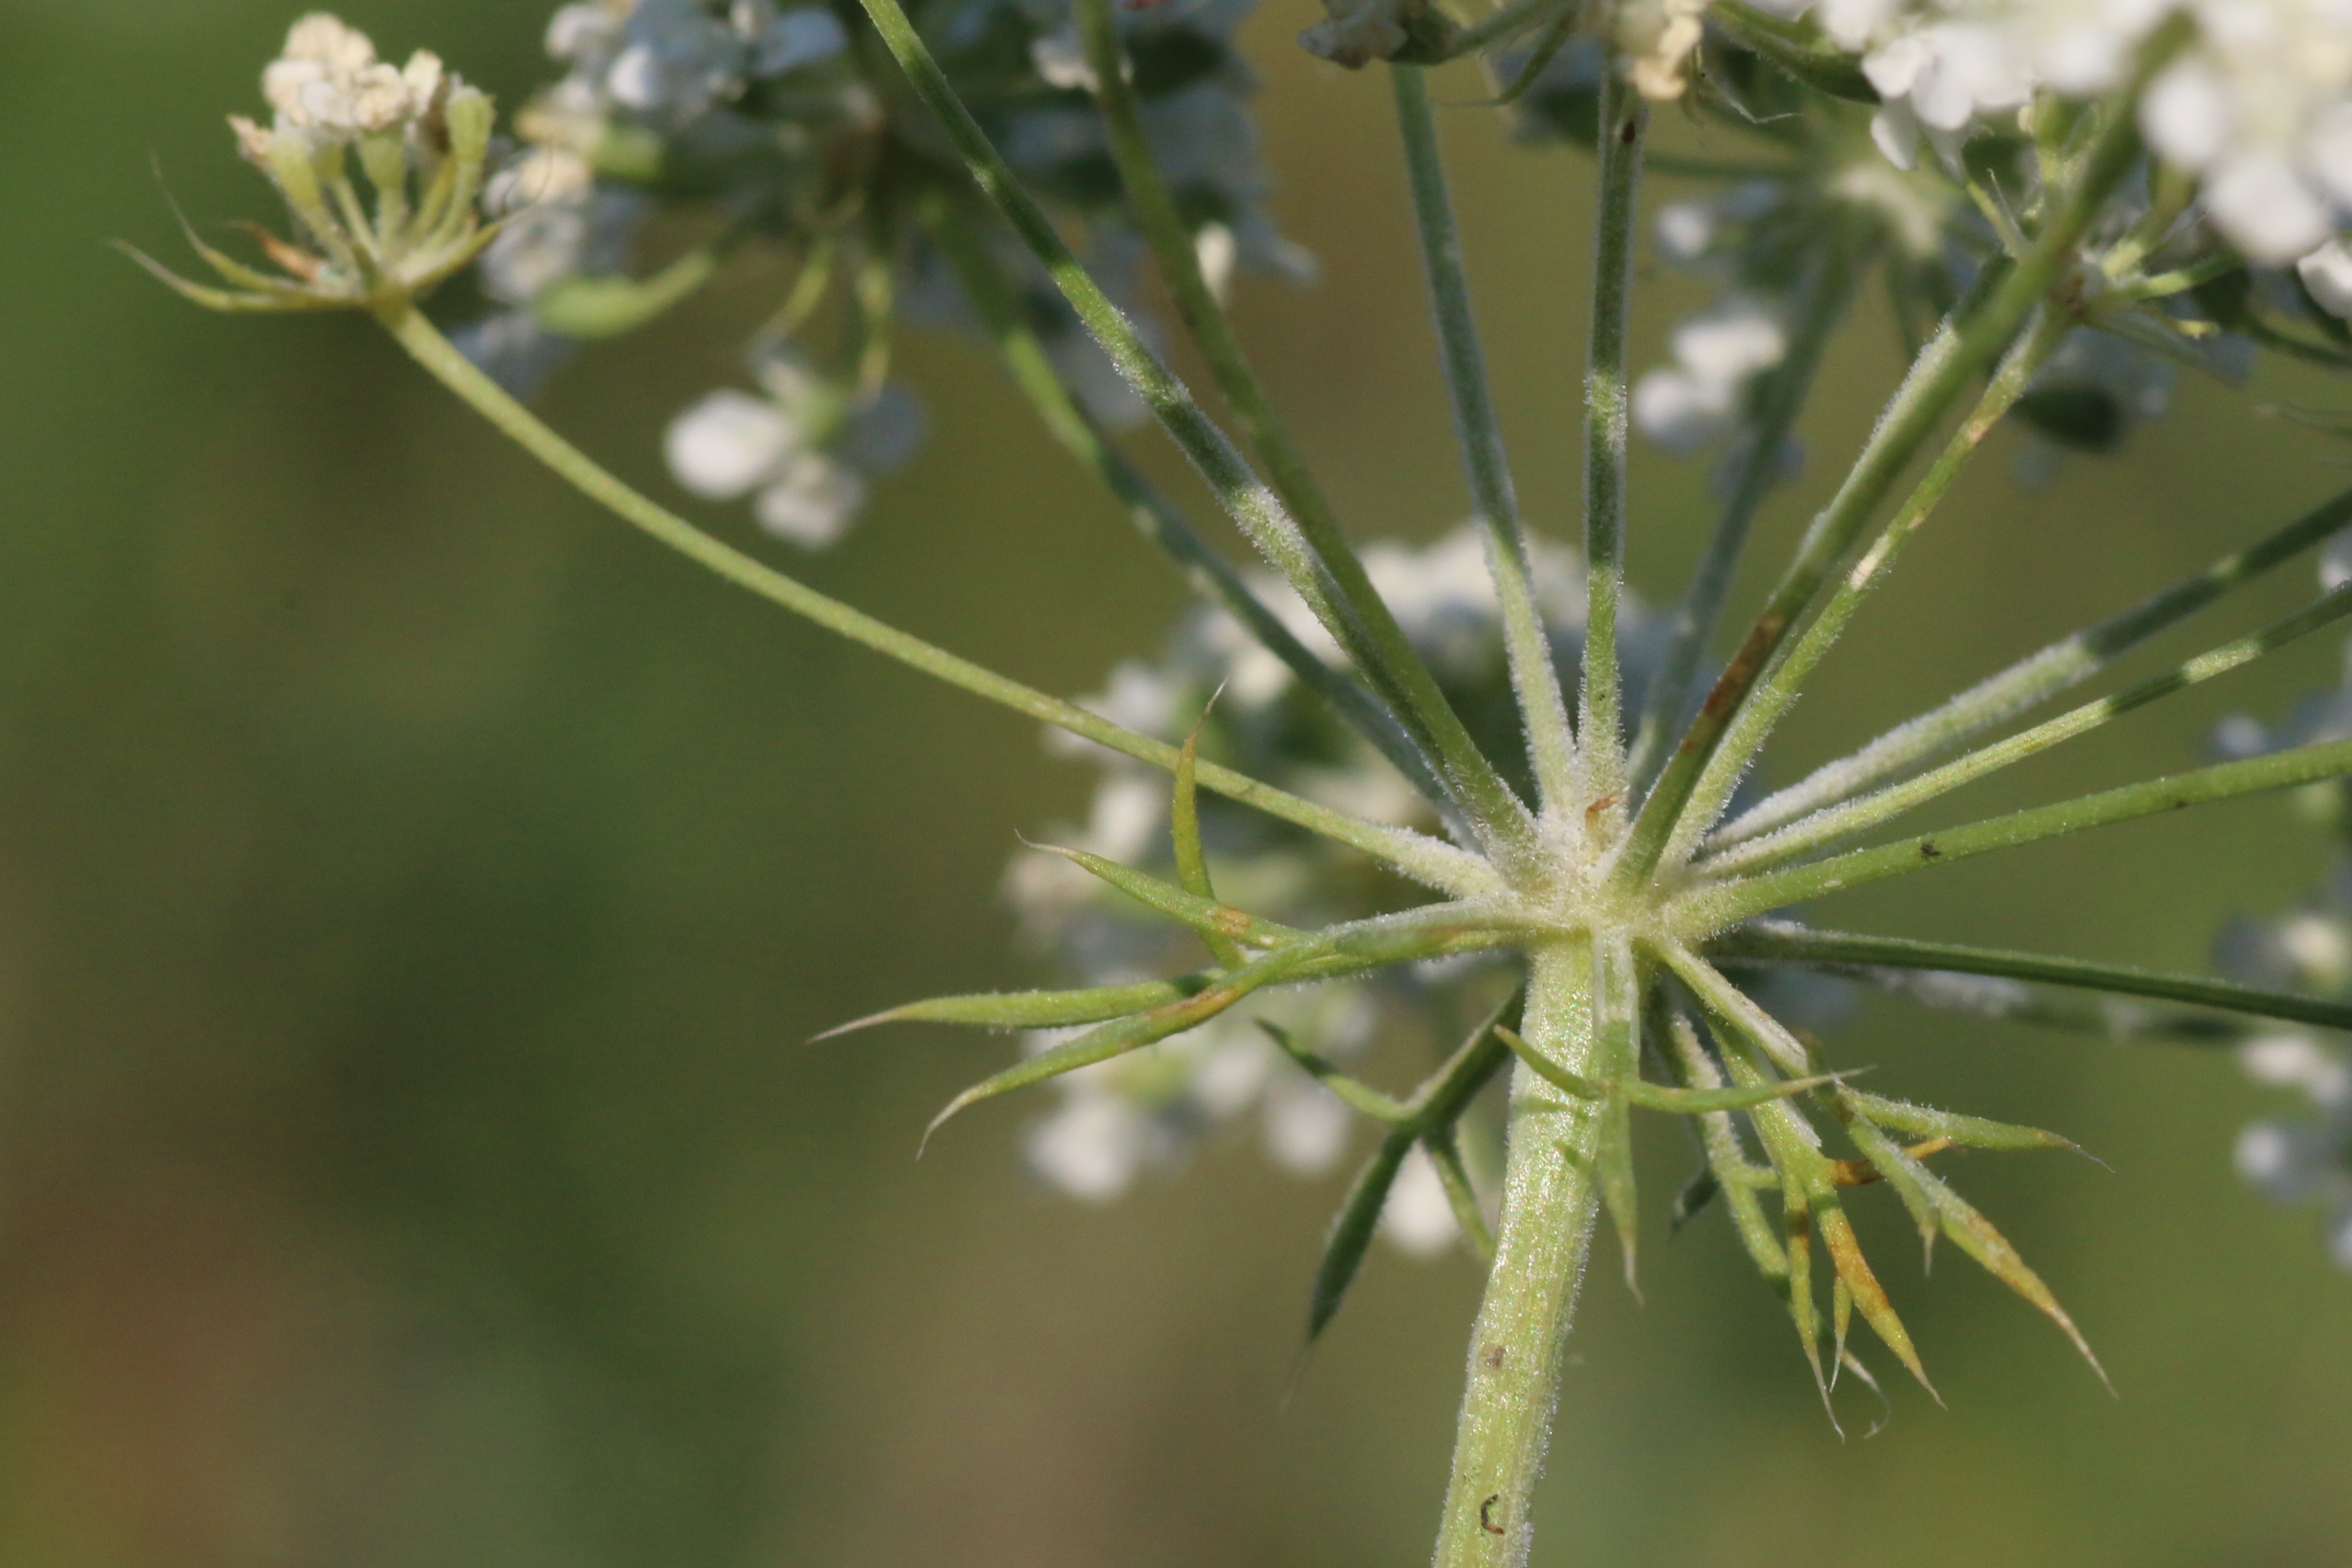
[0,0,2352,1568]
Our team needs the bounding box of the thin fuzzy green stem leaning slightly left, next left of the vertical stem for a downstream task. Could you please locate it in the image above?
[1392,61,1576,811]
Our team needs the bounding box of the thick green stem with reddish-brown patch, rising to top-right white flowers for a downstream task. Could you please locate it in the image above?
[1620,36,2183,882]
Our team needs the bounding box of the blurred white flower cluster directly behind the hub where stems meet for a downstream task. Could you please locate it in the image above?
[1004,527,1665,1255]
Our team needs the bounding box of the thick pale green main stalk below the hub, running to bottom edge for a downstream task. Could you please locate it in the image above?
[1435,938,1601,1568]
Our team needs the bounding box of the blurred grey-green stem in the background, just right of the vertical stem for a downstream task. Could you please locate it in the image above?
[1627,242,1856,790]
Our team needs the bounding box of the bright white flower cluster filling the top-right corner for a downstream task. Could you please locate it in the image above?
[1764,0,2352,263]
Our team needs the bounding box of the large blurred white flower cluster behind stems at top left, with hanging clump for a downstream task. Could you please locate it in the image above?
[458,0,1312,548]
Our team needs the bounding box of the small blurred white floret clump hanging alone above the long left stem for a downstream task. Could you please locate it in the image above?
[664,348,922,550]
